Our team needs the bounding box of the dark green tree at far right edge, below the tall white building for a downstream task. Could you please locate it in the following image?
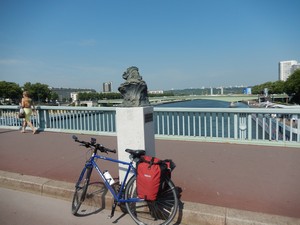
[284,69,300,104]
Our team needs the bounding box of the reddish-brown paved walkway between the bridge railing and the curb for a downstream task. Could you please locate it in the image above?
[0,129,300,218]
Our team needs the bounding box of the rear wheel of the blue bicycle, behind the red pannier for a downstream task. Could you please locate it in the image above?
[125,176,179,225]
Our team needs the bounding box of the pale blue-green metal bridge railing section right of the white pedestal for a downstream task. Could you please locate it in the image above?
[155,108,300,147]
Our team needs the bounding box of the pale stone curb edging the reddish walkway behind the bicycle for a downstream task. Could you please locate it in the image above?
[0,170,300,225]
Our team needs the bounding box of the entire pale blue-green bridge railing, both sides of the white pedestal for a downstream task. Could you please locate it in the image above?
[0,106,300,147]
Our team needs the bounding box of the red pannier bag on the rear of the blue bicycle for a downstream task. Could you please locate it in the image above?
[136,156,175,201]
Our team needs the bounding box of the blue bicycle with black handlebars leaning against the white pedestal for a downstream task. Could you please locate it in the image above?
[72,135,179,225]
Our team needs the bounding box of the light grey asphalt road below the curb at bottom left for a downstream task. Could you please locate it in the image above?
[0,188,134,225]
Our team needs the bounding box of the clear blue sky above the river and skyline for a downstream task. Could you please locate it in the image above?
[0,0,300,92]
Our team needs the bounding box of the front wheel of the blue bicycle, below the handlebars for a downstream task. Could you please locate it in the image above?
[72,166,93,216]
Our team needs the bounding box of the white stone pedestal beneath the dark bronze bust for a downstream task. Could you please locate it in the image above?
[116,106,155,182]
